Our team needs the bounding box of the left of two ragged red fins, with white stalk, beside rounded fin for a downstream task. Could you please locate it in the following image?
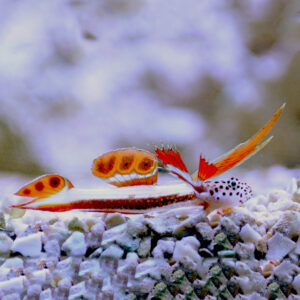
[154,148,195,187]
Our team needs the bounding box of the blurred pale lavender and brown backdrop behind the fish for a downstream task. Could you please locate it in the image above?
[0,0,300,185]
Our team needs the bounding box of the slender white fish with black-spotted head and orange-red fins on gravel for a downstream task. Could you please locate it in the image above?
[13,105,285,214]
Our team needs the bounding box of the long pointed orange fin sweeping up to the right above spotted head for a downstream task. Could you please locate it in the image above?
[193,103,285,180]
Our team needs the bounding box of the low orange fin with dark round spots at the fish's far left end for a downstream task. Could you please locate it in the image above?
[15,174,74,200]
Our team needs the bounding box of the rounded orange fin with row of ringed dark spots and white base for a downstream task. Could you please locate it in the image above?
[92,148,158,187]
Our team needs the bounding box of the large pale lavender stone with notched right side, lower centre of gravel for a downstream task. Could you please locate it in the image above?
[173,236,202,270]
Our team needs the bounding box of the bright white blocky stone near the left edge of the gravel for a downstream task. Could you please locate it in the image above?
[11,232,43,257]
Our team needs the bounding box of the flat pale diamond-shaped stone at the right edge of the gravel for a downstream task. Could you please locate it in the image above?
[267,232,296,260]
